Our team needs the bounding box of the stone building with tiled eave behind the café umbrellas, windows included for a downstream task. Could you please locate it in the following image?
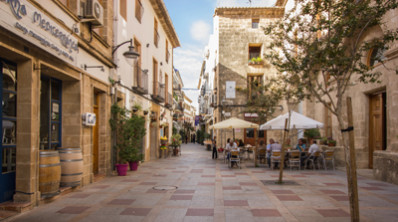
[208,7,284,146]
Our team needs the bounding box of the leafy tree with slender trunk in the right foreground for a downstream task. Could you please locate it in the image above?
[265,0,398,221]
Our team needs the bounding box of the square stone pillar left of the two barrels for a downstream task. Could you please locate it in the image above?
[14,60,40,204]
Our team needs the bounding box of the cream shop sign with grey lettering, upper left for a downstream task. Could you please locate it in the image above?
[0,0,79,65]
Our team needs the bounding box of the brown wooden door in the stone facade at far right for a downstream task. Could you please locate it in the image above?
[369,93,386,169]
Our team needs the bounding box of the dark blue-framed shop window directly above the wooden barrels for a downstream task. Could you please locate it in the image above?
[40,76,62,150]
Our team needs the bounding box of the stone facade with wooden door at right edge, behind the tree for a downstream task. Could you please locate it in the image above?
[306,6,398,184]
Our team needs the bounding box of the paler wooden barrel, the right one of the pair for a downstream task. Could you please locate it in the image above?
[58,148,83,187]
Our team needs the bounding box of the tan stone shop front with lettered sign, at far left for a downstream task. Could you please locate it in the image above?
[0,0,115,206]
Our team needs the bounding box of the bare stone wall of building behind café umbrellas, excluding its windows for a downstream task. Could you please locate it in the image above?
[215,8,286,144]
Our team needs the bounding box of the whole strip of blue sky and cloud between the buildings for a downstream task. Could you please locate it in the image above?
[164,0,217,113]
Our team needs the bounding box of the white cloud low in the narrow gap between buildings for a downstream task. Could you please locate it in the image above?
[174,45,203,114]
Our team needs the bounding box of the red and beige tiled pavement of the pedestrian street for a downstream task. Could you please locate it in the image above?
[9,144,398,222]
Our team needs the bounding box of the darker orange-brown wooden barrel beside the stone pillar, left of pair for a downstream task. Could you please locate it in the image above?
[39,150,61,198]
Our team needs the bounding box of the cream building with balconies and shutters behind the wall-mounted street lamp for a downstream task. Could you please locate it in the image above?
[112,0,180,161]
